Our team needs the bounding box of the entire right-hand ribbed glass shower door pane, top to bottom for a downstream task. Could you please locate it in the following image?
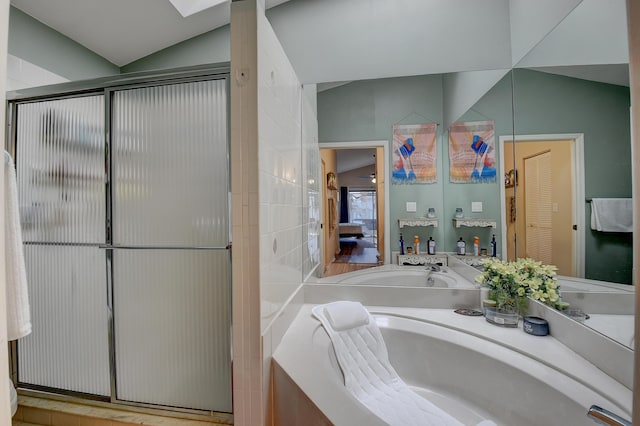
[110,80,232,412]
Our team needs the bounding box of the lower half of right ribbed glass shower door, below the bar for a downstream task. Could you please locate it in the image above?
[113,249,232,412]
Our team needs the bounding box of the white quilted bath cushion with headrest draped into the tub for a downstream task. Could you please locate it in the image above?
[312,301,495,426]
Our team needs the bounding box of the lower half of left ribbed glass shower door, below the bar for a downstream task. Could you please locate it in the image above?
[18,245,110,396]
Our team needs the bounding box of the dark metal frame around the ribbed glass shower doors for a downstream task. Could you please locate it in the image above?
[6,64,232,419]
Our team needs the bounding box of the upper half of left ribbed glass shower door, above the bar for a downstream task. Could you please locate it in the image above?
[16,95,106,243]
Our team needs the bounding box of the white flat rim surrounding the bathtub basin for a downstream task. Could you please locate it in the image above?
[273,304,632,425]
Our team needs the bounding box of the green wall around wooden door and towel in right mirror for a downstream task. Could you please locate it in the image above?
[514,69,633,283]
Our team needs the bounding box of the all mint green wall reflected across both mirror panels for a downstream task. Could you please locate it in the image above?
[318,69,632,283]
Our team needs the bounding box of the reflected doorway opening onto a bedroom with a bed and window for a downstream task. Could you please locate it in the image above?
[320,141,390,276]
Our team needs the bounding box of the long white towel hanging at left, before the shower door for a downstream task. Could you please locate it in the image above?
[4,151,31,340]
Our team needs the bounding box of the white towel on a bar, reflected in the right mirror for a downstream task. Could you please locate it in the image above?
[591,198,633,232]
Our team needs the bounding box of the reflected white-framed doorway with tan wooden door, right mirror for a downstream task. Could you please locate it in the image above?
[500,134,585,277]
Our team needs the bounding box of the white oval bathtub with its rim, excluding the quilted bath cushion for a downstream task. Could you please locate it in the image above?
[273,305,632,426]
